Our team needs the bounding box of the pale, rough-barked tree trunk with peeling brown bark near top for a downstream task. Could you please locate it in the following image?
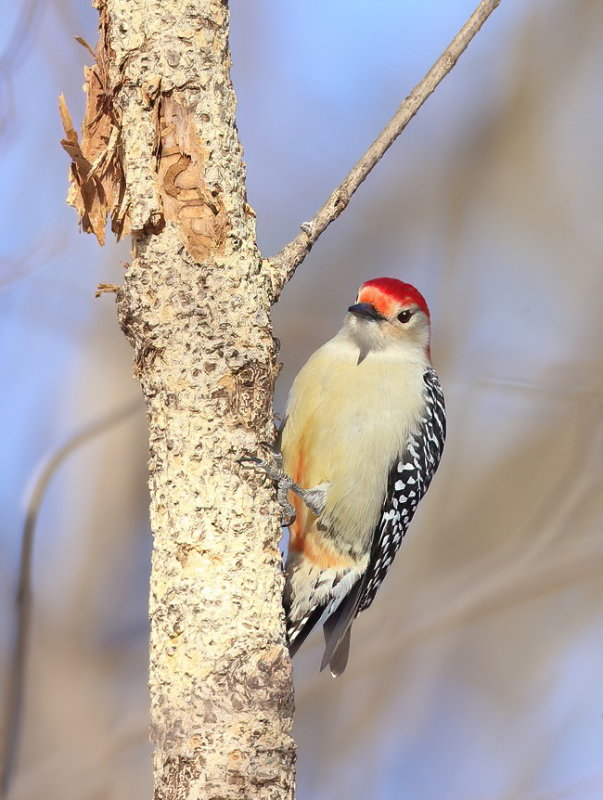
[67,0,294,800]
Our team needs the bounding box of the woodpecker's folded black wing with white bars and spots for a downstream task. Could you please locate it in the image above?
[357,369,446,613]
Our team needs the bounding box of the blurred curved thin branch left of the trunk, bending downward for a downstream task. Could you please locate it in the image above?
[0,399,141,800]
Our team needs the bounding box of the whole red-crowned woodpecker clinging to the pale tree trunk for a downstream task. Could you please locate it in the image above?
[258,278,446,677]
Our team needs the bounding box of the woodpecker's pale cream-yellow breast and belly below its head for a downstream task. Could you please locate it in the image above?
[282,340,426,552]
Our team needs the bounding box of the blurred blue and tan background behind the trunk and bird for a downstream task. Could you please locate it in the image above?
[0,0,603,800]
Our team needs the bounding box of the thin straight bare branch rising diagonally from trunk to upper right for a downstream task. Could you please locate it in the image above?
[268,0,500,297]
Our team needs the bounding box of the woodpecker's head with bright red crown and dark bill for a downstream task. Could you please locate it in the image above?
[343,278,430,363]
